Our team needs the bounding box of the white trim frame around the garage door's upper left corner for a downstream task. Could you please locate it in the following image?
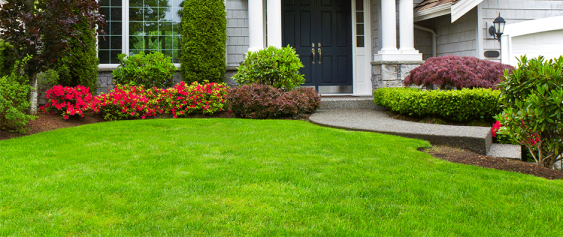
[500,16,563,65]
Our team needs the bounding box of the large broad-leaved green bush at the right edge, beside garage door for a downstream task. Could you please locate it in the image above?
[495,56,563,168]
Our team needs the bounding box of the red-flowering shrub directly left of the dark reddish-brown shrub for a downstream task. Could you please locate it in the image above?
[159,82,228,118]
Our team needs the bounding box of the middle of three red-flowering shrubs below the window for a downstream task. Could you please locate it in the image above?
[98,84,164,120]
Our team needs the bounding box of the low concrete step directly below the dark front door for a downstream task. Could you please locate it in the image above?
[319,96,381,110]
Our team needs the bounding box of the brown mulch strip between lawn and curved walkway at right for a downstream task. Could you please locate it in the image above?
[423,145,563,179]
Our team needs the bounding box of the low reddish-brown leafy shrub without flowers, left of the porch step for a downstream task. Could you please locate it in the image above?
[227,84,321,119]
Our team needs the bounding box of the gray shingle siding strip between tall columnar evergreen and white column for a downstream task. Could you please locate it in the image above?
[226,0,248,67]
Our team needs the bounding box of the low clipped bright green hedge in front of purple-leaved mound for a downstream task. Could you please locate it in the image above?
[373,88,501,122]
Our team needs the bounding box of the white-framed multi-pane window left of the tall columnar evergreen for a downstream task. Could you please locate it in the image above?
[98,0,183,64]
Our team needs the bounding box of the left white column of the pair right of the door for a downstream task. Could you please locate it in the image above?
[379,0,398,54]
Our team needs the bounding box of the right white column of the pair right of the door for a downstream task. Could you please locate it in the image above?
[399,0,418,53]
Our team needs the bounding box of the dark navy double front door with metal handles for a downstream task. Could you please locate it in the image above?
[282,0,353,90]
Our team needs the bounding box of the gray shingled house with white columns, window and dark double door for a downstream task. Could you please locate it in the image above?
[87,0,563,95]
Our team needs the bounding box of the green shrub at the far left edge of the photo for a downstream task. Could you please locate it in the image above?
[0,57,35,134]
